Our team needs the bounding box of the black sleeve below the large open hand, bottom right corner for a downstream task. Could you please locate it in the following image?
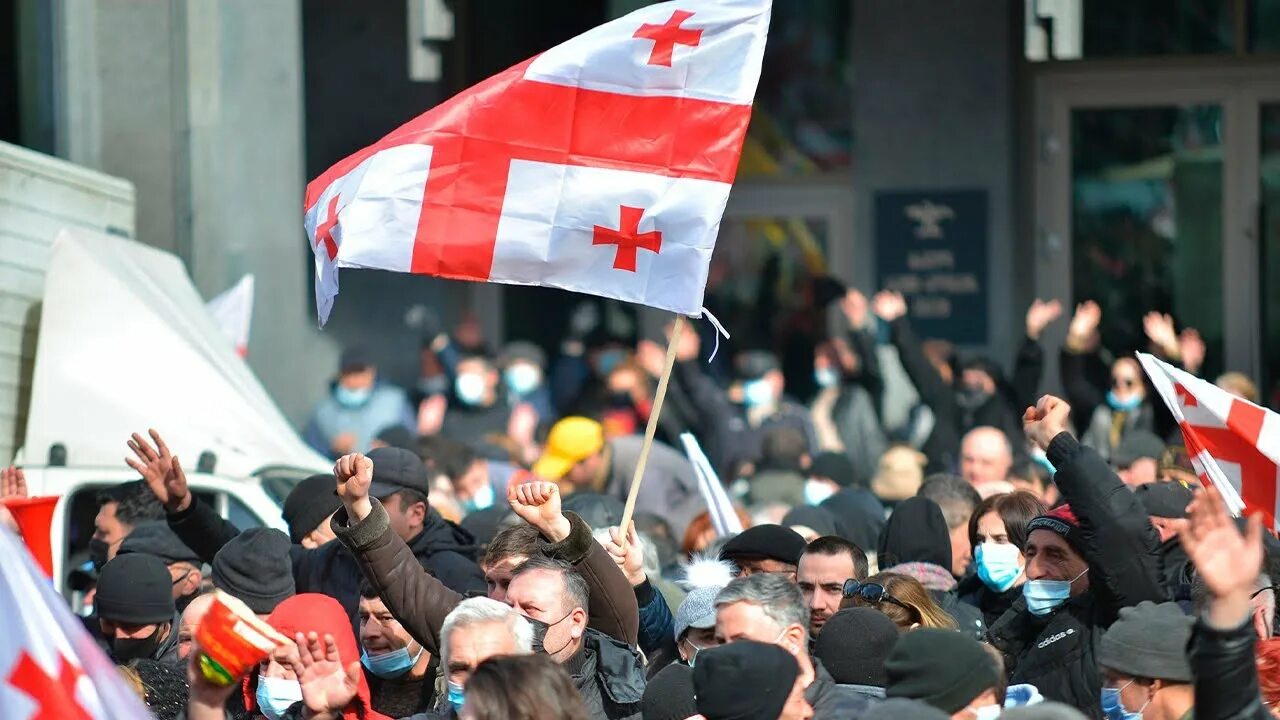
[1188,609,1271,720]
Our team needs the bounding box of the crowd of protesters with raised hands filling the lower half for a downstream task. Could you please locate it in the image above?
[0,290,1280,720]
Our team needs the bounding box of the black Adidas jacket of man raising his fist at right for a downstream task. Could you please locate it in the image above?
[988,433,1166,720]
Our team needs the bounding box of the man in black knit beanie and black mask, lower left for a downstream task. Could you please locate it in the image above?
[93,552,180,665]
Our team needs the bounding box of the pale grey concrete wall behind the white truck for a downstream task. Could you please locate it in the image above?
[34,0,335,424]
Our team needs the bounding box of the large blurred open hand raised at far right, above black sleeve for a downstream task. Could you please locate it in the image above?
[1178,487,1262,628]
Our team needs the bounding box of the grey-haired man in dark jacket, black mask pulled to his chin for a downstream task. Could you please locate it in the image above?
[507,556,644,720]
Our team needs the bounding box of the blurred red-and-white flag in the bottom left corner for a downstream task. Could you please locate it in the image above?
[0,528,153,720]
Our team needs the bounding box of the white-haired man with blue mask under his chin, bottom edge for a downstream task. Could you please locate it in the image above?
[435,597,534,719]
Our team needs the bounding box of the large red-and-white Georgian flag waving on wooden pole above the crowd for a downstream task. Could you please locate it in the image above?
[305,0,771,324]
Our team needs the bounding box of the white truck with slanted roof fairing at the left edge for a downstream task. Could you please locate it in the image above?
[0,143,332,589]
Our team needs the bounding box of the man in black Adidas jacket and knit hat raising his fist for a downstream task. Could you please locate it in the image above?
[988,396,1165,717]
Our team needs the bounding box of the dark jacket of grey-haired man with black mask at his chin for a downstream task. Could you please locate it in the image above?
[566,628,645,720]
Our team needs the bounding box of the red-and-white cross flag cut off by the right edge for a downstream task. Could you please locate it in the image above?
[1138,352,1280,530]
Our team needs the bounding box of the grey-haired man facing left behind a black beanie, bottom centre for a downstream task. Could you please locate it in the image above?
[716,574,869,720]
